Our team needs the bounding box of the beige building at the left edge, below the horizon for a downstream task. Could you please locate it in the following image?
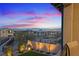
[0,28,14,37]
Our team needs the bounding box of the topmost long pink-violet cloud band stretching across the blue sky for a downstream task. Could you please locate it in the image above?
[3,11,61,17]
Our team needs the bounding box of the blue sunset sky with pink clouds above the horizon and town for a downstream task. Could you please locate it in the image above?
[0,3,62,29]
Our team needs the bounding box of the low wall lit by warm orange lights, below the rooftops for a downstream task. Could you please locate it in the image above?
[27,40,60,53]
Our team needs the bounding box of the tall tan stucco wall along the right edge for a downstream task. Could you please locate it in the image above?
[64,4,79,56]
